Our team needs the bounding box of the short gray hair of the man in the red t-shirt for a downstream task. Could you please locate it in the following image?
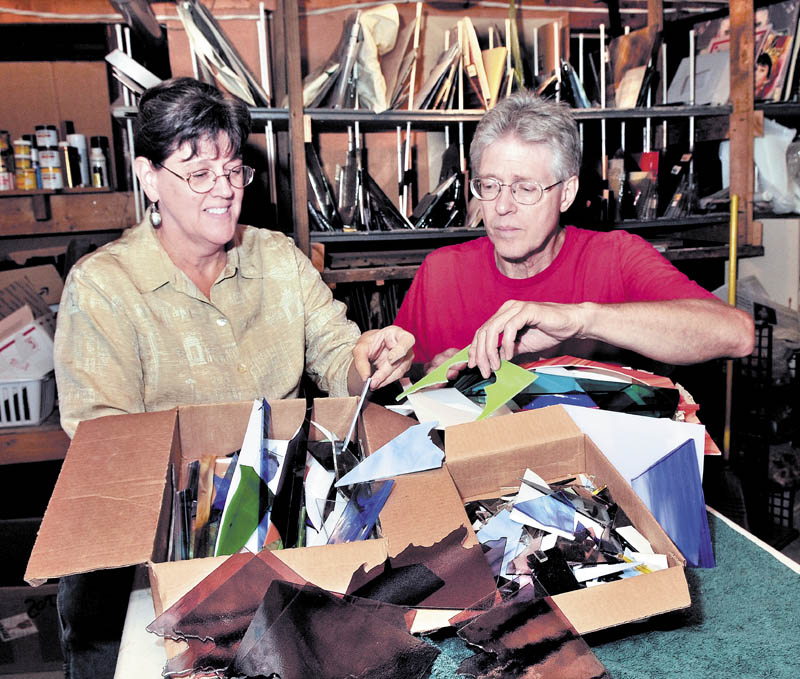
[469,91,581,181]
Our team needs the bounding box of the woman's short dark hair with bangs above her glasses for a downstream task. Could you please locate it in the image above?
[133,78,250,164]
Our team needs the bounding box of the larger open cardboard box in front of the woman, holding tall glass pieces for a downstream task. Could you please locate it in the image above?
[25,398,477,600]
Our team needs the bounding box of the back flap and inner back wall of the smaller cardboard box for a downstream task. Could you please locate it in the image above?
[445,406,584,502]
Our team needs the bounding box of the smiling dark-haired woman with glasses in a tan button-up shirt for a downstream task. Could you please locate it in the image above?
[55,78,414,679]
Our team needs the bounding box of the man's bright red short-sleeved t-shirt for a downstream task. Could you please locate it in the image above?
[395,226,715,362]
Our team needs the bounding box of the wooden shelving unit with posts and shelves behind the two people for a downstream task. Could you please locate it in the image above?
[0,0,780,464]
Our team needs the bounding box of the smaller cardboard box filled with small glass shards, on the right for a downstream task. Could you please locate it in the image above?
[445,406,691,634]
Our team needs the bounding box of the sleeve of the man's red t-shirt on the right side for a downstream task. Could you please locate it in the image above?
[618,233,716,302]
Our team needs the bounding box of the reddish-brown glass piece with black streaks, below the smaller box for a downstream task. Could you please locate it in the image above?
[458,587,610,679]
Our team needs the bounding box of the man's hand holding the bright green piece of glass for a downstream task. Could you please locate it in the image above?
[467,300,584,377]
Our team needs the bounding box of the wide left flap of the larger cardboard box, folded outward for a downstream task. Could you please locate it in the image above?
[25,409,177,584]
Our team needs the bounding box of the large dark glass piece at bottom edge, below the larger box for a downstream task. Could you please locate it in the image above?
[232,581,439,679]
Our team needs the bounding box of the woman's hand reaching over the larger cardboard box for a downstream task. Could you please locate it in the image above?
[351,325,414,393]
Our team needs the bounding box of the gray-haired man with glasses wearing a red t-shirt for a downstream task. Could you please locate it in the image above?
[395,92,754,377]
